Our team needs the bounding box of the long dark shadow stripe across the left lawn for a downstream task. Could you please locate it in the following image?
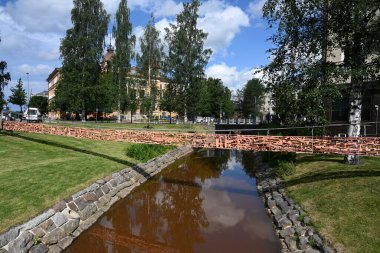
[2,132,150,178]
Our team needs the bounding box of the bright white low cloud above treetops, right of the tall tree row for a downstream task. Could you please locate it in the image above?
[206,62,262,90]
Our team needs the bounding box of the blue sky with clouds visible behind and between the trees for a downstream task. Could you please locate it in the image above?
[0,0,273,105]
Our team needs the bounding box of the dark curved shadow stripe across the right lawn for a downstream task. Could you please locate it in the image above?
[284,170,380,187]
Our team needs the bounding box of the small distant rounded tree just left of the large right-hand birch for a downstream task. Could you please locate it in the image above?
[242,78,265,118]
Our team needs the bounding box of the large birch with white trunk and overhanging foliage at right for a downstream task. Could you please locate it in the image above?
[263,0,380,163]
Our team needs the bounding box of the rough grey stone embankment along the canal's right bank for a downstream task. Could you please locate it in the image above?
[255,156,336,253]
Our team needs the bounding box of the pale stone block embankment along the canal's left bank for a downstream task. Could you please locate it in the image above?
[0,146,193,253]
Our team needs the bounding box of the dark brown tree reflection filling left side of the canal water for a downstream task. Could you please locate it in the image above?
[67,150,233,253]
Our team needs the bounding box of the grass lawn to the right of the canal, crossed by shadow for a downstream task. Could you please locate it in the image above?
[285,155,380,252]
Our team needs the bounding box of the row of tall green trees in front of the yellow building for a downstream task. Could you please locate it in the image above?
[51,0,262,121]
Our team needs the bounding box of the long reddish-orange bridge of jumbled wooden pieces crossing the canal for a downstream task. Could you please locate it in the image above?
[4,121,380,156]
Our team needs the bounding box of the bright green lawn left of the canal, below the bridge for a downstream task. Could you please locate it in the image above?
[0,133,172,232]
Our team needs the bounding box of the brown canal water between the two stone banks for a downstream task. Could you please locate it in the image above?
[65,150,280,253]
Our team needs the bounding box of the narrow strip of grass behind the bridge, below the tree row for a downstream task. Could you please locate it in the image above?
[46,121,210,132]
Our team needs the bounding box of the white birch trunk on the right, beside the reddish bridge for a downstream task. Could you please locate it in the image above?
[344,78,363,165]
